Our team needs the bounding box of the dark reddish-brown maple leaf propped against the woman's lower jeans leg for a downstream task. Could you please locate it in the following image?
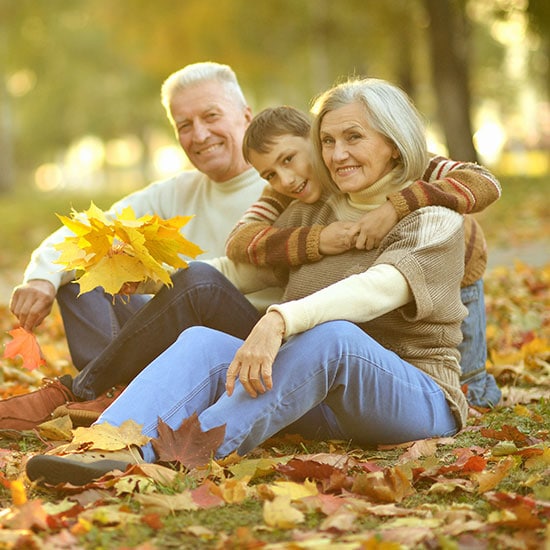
[151,413,225,469]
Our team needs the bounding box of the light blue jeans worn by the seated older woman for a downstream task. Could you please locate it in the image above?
[97,321,457,462]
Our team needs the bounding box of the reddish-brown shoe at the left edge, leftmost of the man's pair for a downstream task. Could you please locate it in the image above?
[0,378,76,430]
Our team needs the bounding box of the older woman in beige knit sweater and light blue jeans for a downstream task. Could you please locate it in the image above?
[27,79,468,483]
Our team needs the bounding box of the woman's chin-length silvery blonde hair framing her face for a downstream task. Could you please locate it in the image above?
[311,78,428,190]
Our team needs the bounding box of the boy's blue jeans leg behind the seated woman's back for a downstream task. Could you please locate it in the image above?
[458,279,502,407]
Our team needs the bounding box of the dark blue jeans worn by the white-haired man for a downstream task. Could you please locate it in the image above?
[59,262,260,400]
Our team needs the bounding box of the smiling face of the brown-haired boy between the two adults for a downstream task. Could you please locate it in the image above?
[248,134,322,204]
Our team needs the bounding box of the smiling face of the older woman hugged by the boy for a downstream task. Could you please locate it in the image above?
[320,102,399,193]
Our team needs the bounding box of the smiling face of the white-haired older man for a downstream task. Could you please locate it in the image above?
[170,81,252,182]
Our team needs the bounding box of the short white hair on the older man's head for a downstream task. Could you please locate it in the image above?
[160,61,247,124]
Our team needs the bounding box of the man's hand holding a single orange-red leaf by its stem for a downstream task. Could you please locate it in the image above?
[10,279,56,332]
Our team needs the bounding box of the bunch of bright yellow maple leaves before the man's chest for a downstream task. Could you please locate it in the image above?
[55,202,203,294]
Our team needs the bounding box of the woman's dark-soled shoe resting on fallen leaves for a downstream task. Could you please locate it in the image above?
[26,455,128,485]
